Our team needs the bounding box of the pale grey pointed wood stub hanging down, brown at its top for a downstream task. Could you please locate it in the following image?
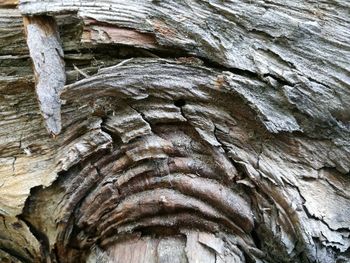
[23,15,66,137]
